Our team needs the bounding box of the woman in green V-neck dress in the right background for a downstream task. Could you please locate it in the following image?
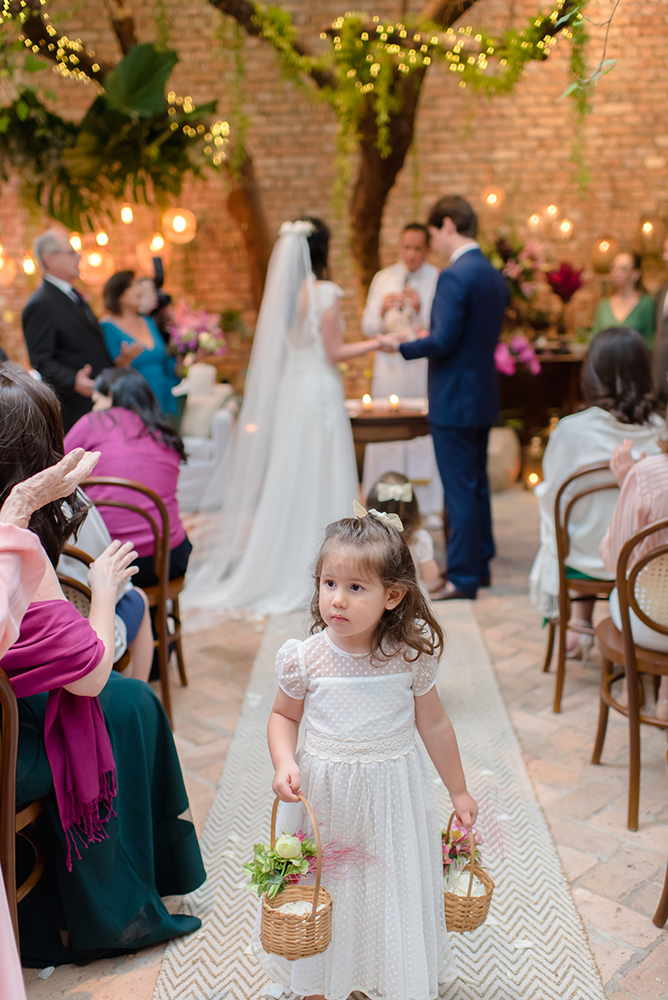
[591,253,656,348]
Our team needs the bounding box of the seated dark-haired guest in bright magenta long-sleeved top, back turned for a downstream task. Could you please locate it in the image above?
[65,368,192,587]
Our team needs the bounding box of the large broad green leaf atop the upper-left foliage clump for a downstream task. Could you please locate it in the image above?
[103,45,179,118]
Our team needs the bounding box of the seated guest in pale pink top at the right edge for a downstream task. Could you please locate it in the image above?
[599,437,668,719]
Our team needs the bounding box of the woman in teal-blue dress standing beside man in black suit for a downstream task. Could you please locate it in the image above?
[100,271,179,417]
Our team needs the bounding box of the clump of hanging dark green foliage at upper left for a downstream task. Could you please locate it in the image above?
[0,45,229,230]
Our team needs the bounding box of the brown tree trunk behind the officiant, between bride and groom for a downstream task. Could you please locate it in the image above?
[349,70,424,308]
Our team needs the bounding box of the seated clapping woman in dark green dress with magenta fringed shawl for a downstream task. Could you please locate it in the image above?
[0,369,205,968]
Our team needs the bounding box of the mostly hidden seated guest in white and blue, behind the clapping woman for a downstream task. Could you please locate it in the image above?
[57,504,153,681]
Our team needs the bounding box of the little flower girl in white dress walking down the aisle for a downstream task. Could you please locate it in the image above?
[253,504,477,1000]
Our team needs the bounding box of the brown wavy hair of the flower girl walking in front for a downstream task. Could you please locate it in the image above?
[311,514,443,666]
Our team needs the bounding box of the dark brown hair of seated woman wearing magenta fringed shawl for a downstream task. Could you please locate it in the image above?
[0,363,89,566]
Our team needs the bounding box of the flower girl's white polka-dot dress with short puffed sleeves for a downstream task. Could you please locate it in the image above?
[252,631,457,1000]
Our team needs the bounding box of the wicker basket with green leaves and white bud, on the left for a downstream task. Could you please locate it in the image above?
[260,795,332,961]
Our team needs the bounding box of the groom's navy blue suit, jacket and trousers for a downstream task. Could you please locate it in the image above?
[400,247,509,597]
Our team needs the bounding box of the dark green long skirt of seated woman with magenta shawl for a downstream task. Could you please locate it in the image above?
[16,671,206,968]
